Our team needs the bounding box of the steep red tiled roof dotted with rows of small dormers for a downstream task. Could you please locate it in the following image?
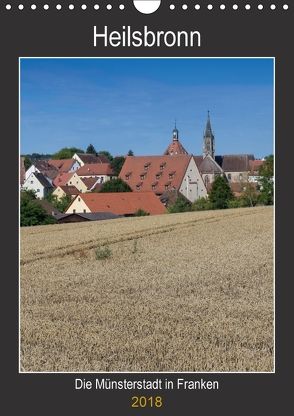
[119,155,191,194]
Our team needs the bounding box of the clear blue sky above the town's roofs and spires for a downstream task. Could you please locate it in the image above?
[20,58,273,158]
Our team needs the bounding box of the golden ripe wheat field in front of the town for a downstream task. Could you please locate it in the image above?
[20,207,274,372]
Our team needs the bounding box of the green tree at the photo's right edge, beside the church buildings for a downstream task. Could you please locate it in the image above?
[259,155,274,205]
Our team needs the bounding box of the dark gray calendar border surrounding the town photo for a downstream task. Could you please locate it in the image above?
[0,2,294,415]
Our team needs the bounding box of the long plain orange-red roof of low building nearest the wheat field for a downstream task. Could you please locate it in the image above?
[72,192,166,215]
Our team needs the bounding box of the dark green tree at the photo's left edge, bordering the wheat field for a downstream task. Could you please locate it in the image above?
[20,191,56,227]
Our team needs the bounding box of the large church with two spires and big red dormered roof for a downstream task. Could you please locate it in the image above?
[119,113,261,203]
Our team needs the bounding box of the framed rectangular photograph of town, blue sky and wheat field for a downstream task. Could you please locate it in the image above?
[19,58,275,372]
